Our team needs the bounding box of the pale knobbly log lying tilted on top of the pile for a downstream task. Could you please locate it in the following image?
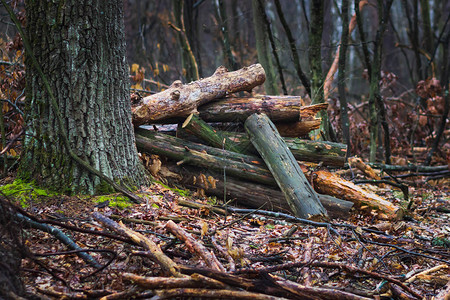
[132,64,266,126]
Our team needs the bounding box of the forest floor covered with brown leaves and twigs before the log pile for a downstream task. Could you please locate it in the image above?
[3,169,450,299]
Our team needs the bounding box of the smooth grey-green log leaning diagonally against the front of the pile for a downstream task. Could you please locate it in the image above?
[244,114,327,219]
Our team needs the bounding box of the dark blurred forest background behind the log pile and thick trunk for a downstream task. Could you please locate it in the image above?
[0,0,450,163]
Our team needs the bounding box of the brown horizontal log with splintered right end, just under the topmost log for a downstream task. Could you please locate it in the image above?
[198,95,328,122]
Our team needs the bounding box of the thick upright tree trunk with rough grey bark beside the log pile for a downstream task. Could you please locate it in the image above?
[19,0,144,193]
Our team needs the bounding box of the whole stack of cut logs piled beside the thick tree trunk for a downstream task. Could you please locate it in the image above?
[132,64,402,219]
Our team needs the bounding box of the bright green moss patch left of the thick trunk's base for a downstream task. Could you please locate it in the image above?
[0,179,58,207]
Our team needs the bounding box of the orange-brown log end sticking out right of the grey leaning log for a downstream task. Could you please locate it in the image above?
[313,170,404,220]
